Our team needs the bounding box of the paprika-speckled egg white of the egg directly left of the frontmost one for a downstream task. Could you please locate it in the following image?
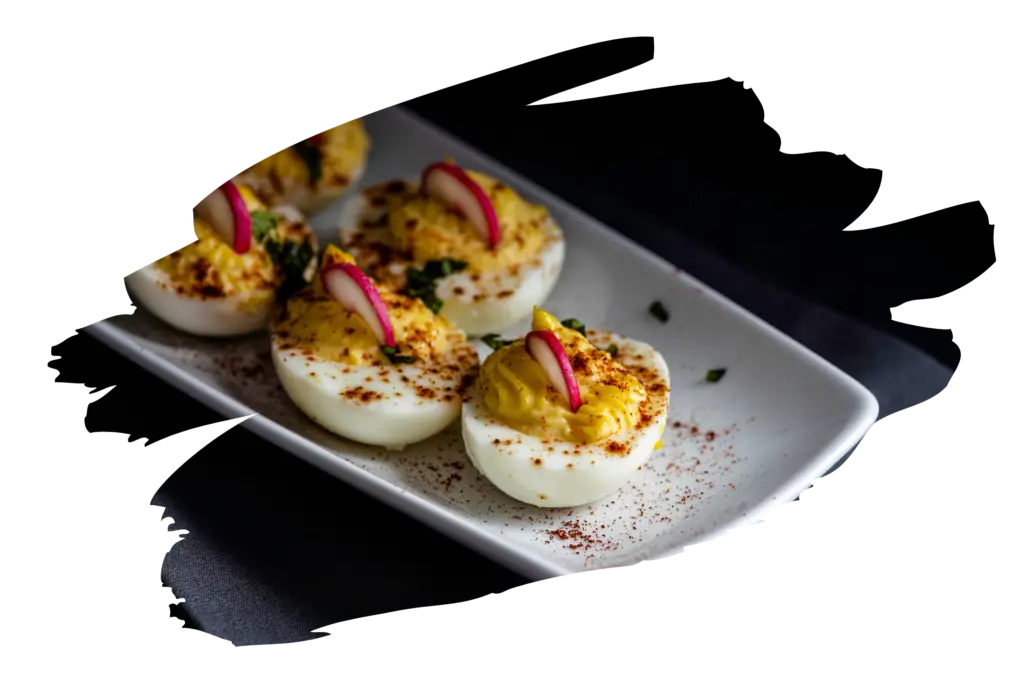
[270,335,474,449]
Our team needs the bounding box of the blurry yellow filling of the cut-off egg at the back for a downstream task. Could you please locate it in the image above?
[244,117,370,192]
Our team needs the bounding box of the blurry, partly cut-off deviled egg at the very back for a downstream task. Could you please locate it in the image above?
[233,116,372,215]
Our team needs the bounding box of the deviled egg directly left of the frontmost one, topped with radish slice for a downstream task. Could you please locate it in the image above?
[270,245,479,449]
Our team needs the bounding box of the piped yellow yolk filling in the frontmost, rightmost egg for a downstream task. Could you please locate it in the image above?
[479,308,647,444]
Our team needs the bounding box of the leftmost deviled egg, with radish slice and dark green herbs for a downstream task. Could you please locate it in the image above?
[124,180,317,337]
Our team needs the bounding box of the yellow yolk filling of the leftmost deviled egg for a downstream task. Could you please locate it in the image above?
[154,186,280,303]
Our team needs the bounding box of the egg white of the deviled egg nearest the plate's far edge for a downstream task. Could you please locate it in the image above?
[339,182,565,336]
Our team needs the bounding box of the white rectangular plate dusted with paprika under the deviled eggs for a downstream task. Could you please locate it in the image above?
[84,105,879,581]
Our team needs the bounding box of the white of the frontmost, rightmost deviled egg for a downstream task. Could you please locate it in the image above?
[462,332,670,508]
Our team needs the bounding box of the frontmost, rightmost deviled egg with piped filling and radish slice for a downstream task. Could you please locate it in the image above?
[462,308,669,508]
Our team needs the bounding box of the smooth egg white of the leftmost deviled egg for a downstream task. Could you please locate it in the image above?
[124,257,274,337]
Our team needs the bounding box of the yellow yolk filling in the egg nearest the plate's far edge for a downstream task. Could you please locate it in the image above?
[388,166,548,272]
